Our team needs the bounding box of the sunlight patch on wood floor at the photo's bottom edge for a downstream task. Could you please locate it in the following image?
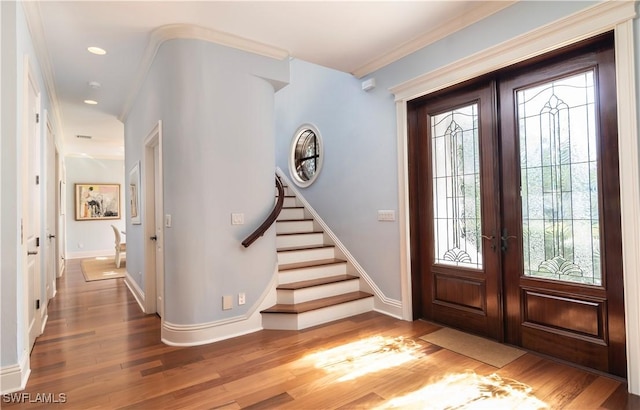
[377,371,549,410]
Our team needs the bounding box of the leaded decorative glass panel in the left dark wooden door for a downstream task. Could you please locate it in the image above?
[431,104,482,269]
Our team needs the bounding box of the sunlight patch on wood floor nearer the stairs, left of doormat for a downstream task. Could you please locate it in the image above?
[306,336,422,382]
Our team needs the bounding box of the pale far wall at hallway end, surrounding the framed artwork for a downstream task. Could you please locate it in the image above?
[65,157,127,259]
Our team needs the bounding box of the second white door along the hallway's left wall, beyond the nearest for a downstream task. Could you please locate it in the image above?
[43,117,58,300]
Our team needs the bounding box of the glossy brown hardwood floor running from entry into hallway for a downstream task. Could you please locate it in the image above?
[6,261,640,409]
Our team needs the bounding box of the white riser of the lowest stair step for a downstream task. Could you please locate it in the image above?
[262,297,373,330]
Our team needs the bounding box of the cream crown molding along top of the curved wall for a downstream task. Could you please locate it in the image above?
[118,24,289,122]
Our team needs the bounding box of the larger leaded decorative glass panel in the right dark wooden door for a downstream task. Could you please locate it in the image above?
[516,71,602,285]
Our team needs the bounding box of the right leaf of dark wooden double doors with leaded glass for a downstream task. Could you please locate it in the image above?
[499,36,626,377]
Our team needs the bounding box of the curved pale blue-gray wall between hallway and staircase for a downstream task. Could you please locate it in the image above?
[125,40,289,325]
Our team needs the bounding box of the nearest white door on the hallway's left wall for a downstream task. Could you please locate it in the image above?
[22,59,42,351]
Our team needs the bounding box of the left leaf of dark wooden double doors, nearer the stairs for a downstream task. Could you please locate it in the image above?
[409,81,502,339]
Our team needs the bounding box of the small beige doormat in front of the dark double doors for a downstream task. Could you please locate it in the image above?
[420,328,526,368]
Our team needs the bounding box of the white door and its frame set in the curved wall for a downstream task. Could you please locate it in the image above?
[142,121,164,315]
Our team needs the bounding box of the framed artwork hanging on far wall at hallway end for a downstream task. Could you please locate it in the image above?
[75,184,120,221]
